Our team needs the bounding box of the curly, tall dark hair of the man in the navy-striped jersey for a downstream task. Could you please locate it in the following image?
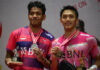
[27,1,46,15]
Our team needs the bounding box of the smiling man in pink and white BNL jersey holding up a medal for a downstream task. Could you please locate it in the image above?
[51,6,100,70]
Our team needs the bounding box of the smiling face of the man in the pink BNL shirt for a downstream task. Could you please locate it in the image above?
[60,10,78,30]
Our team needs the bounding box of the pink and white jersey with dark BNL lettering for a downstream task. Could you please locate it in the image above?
[52,32,99,68]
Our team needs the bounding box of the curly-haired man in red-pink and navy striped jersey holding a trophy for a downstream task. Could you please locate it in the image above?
[5,1,54,70]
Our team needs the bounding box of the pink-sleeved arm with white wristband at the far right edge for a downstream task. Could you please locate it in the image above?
[88,38,100,70]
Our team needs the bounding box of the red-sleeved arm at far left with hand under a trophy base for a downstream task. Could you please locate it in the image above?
[5,32,22,68]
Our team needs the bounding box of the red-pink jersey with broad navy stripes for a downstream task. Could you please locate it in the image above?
[7,26,54,70]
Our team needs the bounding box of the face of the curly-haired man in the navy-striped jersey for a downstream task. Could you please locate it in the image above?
[28,7,45,27]
